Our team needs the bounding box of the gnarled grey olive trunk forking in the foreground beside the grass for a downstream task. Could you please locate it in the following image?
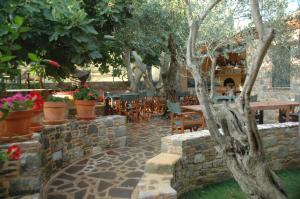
[185,0,287,199]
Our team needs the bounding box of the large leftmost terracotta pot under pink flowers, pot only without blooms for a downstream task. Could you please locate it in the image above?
[0,110,33,138]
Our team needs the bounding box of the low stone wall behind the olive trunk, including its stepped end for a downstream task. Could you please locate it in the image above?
[133,123,300,199]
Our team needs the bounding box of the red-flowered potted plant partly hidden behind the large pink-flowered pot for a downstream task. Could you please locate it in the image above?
[29,91,44,132]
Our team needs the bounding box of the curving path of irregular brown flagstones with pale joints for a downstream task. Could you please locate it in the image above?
[45,118,171,199]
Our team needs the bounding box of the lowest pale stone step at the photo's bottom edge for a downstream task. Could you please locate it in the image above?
[131,173,177,199]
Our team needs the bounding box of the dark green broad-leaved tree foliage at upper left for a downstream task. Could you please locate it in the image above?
[0,0,131,77]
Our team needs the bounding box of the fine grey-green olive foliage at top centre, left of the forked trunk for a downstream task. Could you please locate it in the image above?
[116,0,187,66]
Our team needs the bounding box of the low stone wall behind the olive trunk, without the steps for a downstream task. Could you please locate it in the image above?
[162,123,300,195]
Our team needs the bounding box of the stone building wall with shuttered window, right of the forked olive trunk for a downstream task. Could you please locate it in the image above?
[253,10,300,100]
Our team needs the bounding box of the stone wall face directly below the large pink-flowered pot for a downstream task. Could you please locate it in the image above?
[0,140,42,198]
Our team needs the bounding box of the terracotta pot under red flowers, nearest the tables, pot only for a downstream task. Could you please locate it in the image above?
[75,100,96,120]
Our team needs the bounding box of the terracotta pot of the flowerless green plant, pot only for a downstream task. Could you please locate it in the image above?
[44,102,67,125]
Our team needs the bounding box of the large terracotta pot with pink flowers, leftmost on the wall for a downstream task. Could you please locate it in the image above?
[0,93,33,138]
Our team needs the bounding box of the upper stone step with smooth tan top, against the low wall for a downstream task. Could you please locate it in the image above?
[145,153,181,174]
